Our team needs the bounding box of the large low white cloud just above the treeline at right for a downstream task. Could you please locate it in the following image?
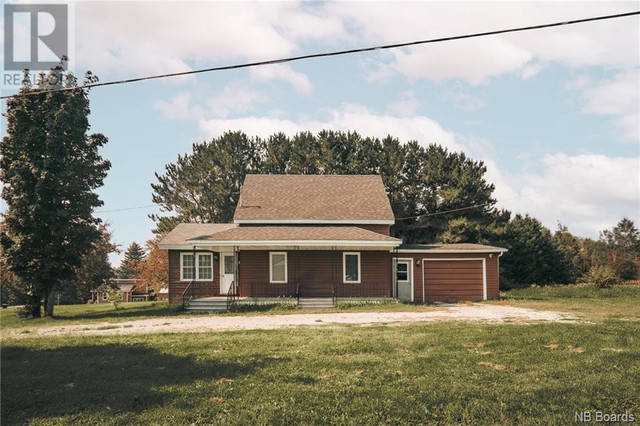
[496,153,640,238]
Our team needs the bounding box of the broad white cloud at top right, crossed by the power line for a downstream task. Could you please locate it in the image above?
[327,2,639,84]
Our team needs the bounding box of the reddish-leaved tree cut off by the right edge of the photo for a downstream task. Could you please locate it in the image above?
[600,217,640,280]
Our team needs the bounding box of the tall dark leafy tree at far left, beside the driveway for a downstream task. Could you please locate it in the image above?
[0,66,111,317]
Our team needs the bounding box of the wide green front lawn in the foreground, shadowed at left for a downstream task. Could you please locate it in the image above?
[1,320,640,425]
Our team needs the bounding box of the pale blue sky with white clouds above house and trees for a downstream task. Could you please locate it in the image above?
[2,1,640,265]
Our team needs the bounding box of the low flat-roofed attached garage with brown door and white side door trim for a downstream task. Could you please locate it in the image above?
[398,244,507,302]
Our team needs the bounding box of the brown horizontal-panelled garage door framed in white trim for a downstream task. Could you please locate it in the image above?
[424,259,484,302]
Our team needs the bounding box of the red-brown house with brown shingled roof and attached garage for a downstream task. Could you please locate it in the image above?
[159,175,506,306]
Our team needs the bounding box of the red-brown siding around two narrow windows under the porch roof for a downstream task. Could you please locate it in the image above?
[239,250,391,297]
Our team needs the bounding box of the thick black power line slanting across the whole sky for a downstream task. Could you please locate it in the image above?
[0,11,640,99]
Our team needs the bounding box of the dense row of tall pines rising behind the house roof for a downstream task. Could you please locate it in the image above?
[151,130,500,243]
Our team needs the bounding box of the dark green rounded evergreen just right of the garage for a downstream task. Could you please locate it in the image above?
[501,214,565,285]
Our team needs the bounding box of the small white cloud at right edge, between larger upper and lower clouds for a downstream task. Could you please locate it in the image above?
[584,69,640,141]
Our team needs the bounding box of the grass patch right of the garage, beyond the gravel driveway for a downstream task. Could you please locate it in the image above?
[489,284,640,321]
